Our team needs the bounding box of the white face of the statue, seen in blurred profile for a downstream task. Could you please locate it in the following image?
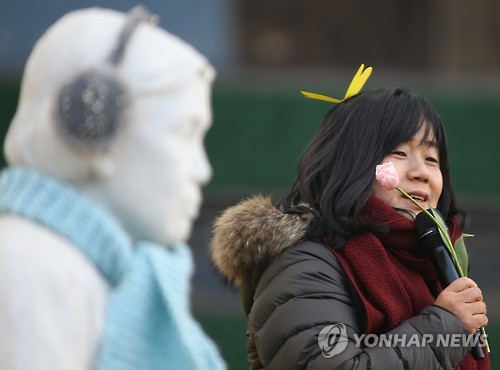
[100,71,212,244]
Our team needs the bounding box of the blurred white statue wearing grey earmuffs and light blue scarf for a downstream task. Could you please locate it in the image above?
[0,8,225,370]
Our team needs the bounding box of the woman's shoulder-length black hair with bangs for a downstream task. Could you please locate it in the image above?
[278,88,463,248]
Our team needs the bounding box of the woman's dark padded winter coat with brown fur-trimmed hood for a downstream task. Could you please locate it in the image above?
[212,197,469,370]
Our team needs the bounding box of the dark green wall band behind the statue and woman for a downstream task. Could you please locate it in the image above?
[0,84,500,206]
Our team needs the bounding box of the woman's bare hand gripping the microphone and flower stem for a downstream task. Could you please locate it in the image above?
[435,277,488,334]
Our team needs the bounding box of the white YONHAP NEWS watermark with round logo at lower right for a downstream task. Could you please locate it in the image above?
[318,323,486,358]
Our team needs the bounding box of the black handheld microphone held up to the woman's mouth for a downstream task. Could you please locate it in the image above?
[415,210,484,360]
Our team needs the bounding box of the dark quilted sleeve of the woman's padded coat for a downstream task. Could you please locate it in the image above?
[248,242,469,370]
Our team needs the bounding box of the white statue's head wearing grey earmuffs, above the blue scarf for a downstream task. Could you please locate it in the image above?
[4,8,215,244]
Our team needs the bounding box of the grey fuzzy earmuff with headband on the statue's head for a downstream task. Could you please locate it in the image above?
[56,6,157,150]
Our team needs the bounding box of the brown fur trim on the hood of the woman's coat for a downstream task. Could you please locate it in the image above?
[211,195,314,287]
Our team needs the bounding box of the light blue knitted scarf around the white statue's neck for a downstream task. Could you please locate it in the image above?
[0,168,226,370]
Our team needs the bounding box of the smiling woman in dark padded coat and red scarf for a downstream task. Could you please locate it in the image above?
[212,72,489,369]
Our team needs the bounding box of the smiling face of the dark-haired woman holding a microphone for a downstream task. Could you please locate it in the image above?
[373,123,443,219]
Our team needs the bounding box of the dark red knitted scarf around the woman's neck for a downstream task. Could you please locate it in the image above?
[330,197,490,370]
